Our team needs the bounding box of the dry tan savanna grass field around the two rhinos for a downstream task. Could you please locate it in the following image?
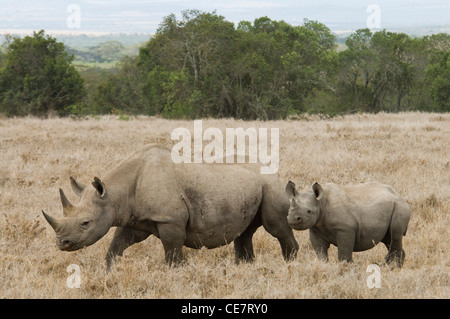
[0,113,450,298]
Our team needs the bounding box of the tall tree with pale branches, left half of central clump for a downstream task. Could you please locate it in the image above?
[139,10,234,117]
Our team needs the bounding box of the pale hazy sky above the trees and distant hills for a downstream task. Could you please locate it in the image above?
[0,0,450,33]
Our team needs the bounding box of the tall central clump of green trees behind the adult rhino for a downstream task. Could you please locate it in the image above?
[139,10,337,119]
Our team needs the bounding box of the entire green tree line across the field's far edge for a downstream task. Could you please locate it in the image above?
[0,10,450,120]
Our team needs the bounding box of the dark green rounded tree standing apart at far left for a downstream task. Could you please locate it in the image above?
[0,30,84,116]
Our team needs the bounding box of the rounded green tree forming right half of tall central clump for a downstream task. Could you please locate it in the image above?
[233,17,337,119]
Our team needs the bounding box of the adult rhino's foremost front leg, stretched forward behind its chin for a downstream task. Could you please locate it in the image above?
[106,227,151,270]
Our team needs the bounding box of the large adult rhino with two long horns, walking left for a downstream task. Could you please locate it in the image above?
[43,144,298,269]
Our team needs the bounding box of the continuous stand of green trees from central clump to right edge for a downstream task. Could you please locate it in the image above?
[99,10,450,120]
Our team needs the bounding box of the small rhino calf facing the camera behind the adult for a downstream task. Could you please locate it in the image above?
[285,182,411,267]
